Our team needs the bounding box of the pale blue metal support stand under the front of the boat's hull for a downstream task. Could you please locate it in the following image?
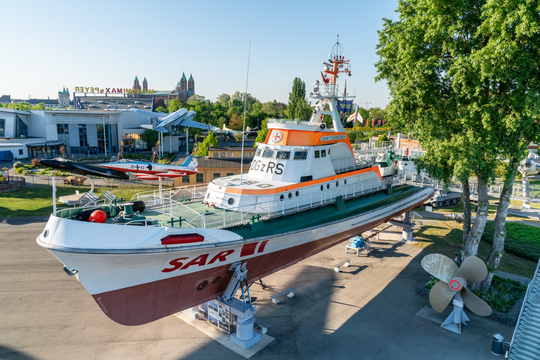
[219,263,261,349]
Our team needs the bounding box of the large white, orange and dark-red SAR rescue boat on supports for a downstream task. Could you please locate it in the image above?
[37,42,433,325]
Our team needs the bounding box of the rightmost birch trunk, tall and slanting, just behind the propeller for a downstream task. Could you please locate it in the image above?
[479,160,519,290]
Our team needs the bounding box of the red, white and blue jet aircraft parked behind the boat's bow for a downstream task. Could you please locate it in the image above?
[100,155,199,180]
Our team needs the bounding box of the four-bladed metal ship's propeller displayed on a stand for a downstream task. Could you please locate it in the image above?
[422,254,491,316]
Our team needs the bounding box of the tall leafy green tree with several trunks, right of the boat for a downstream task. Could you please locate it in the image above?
[376,0,540,287]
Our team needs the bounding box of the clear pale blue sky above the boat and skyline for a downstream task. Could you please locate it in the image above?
[0,0,398,107]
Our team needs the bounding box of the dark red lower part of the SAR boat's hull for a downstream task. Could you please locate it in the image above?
[92,202,421,325]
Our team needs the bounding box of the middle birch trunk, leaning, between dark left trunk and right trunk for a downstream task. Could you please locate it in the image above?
[461,176,489,261]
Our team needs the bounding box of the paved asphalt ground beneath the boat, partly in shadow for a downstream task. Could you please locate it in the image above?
[0,218,513,360]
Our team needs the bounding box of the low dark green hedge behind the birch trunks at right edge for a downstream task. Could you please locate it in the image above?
[482,221,540,261]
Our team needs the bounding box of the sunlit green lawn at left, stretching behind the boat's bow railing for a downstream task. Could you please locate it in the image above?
[0,185,165,217]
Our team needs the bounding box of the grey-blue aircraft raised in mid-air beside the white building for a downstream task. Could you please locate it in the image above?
[131,109,219,133]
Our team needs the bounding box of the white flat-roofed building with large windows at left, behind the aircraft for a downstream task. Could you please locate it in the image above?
[0,108,150,159]
